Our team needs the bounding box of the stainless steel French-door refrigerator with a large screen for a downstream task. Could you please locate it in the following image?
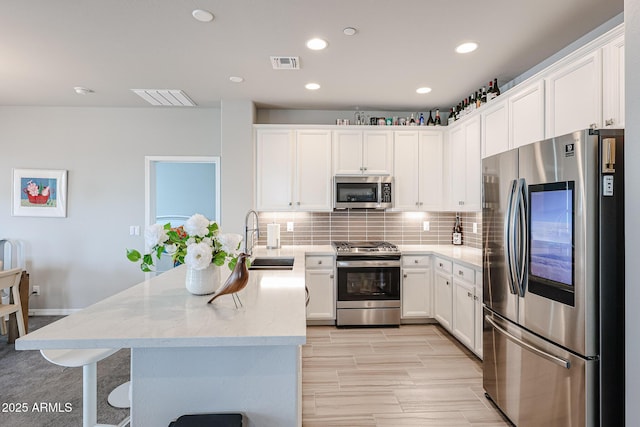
[482,130,625,427]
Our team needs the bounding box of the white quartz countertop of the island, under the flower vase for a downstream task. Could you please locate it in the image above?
[16,256,306,350]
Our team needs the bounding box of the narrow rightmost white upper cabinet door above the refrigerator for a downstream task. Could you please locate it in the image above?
[602,35,625,128]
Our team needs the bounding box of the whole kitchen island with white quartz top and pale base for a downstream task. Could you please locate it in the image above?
[16,257,306,427]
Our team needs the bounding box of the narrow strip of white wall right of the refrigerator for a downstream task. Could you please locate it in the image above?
[624,0,640,427]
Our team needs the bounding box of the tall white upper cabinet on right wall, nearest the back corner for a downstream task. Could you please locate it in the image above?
[448,116,482,211]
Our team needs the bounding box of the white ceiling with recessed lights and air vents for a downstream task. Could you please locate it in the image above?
[0,0,623,111]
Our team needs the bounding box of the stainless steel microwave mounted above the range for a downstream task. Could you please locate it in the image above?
[333,175,393,209]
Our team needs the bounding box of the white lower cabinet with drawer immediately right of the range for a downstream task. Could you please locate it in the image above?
[401,255,432,319]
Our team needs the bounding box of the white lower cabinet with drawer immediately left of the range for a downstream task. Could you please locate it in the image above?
[305,255,336,324]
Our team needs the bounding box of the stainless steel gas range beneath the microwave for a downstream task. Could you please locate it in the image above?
[333,242,400,326]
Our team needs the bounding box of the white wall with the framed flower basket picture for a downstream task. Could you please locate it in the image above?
[0,107,221,309]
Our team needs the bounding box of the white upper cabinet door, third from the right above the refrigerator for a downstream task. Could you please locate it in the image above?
[508,80,544,148]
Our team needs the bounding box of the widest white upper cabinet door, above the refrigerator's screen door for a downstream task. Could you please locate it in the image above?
[545,50,602,138]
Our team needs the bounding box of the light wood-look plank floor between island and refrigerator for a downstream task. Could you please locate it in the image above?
[302,325,510,427]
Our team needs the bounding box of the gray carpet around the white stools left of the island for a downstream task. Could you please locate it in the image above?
[0,316,130,427]
